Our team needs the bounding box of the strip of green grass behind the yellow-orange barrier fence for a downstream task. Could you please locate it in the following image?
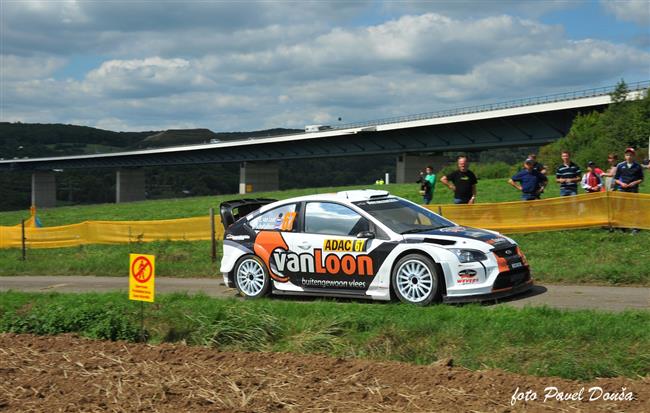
[0,179,650,227]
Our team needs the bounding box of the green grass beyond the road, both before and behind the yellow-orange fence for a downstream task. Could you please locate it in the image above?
[0,179,650,285]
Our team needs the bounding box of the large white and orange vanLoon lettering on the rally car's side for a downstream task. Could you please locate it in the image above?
[271,248,375,276]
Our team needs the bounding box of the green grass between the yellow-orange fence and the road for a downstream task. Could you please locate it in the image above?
[0,229,650,286]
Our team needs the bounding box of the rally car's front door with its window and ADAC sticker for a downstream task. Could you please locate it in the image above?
[281,201,380,295]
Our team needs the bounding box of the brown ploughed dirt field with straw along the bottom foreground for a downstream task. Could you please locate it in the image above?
[0,334,650,413]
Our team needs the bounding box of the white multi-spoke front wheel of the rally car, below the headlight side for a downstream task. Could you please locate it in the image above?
[391,254,441,306]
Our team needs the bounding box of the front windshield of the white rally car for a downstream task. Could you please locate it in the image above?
[355,198,455,234]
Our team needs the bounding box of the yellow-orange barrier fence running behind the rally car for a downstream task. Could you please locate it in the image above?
[0,192,650,248]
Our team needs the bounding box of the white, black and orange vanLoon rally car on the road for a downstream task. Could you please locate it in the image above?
[221,190,533,305]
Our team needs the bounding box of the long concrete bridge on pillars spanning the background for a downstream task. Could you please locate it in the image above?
[0,81,650,207]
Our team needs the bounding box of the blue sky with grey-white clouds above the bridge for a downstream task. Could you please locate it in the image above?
[0,0,650,132]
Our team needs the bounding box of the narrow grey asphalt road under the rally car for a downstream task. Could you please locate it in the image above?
[0,276,650,311]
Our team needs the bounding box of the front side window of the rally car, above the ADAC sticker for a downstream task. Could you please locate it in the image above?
[304,202,370,236]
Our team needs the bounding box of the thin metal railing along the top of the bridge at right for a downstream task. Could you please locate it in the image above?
[332,80,650,129]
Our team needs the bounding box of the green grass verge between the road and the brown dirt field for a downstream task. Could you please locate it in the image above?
[0,292,650,380]
